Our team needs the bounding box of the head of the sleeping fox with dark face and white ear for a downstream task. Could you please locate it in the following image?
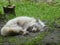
[27,20,45,32]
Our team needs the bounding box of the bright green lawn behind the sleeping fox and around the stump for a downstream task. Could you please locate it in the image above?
[0,1,60,26]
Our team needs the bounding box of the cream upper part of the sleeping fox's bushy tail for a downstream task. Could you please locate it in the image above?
[1,26,23,36]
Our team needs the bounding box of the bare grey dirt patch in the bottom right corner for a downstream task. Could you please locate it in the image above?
[42,28,60,45]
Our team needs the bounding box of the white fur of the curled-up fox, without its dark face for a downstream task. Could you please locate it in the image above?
[1,16,45,36]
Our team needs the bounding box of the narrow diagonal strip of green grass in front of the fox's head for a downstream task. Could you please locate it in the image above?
[26,32,49,45]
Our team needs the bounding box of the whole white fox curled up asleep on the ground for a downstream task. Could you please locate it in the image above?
[1,16,45,36]
